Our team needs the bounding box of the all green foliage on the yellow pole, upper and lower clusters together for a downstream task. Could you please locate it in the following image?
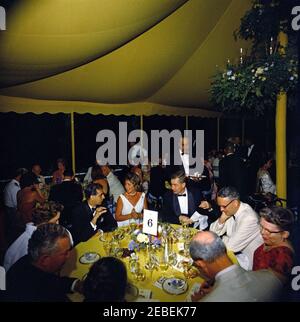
[210,0,298,115]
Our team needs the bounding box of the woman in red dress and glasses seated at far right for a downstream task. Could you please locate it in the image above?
[253,206,294,281]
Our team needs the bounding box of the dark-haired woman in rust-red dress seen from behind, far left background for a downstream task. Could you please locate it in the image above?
[17,172,46,224]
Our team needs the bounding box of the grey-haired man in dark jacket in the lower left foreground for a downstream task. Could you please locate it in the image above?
[6,223,82,302]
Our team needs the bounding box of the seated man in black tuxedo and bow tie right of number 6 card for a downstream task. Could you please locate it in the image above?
[159,171,215,229]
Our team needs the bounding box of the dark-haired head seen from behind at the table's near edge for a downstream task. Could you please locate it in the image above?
[83,257,127,302]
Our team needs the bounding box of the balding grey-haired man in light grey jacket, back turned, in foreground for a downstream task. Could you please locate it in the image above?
[190,231,282,302]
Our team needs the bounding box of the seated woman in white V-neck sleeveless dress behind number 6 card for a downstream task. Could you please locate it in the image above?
[115,173,148,227]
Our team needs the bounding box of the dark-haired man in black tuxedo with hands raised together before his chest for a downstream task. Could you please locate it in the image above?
[70,183,117,244]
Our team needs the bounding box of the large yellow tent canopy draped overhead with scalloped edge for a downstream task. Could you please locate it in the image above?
[0,0,250,117]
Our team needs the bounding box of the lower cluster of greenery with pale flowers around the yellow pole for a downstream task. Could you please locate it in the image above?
[211,53,298,115]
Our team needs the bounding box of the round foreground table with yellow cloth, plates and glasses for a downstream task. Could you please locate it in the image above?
[61,225,237,302]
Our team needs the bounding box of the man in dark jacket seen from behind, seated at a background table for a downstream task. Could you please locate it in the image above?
[49,169,83,228]
